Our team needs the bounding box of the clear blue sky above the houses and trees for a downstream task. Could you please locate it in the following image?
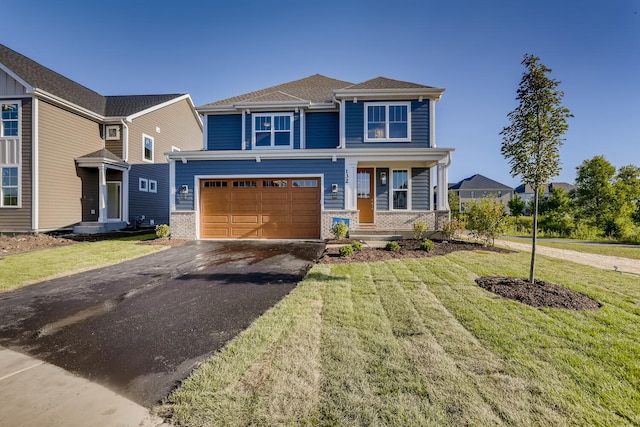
[5,0,640,186]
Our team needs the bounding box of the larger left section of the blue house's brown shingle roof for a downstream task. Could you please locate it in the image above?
[201,74,353,107]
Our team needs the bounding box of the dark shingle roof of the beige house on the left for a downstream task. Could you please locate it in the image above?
[0,44,188,117]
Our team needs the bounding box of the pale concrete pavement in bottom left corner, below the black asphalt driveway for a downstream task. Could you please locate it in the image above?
[0,347,168,427]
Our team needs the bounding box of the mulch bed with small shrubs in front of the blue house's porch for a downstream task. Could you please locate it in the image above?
[318,239,511,264]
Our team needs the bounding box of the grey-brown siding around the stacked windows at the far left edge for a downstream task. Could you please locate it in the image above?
[0,97,34,233]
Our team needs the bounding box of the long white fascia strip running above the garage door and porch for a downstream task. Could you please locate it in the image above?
[164,148,454,162]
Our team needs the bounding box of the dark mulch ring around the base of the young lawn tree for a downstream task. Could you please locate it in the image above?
[476,276,601,310]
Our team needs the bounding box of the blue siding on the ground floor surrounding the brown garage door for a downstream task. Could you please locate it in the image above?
[175,159,344,210]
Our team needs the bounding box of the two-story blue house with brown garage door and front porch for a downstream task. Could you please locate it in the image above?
[168,74,453,239]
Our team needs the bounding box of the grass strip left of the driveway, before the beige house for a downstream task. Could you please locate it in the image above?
[0,234,164,292]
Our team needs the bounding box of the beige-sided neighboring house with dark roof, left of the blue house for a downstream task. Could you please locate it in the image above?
[0,45,202,233]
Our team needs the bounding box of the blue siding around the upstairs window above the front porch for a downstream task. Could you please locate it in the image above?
[345,100,429,148]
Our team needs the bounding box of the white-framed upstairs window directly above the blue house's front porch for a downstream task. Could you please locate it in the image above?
[364,102,411,142]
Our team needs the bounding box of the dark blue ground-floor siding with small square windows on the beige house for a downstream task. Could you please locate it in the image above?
[129,163,170,225]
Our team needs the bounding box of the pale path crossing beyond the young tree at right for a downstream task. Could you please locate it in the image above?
[495,240,640,276]
